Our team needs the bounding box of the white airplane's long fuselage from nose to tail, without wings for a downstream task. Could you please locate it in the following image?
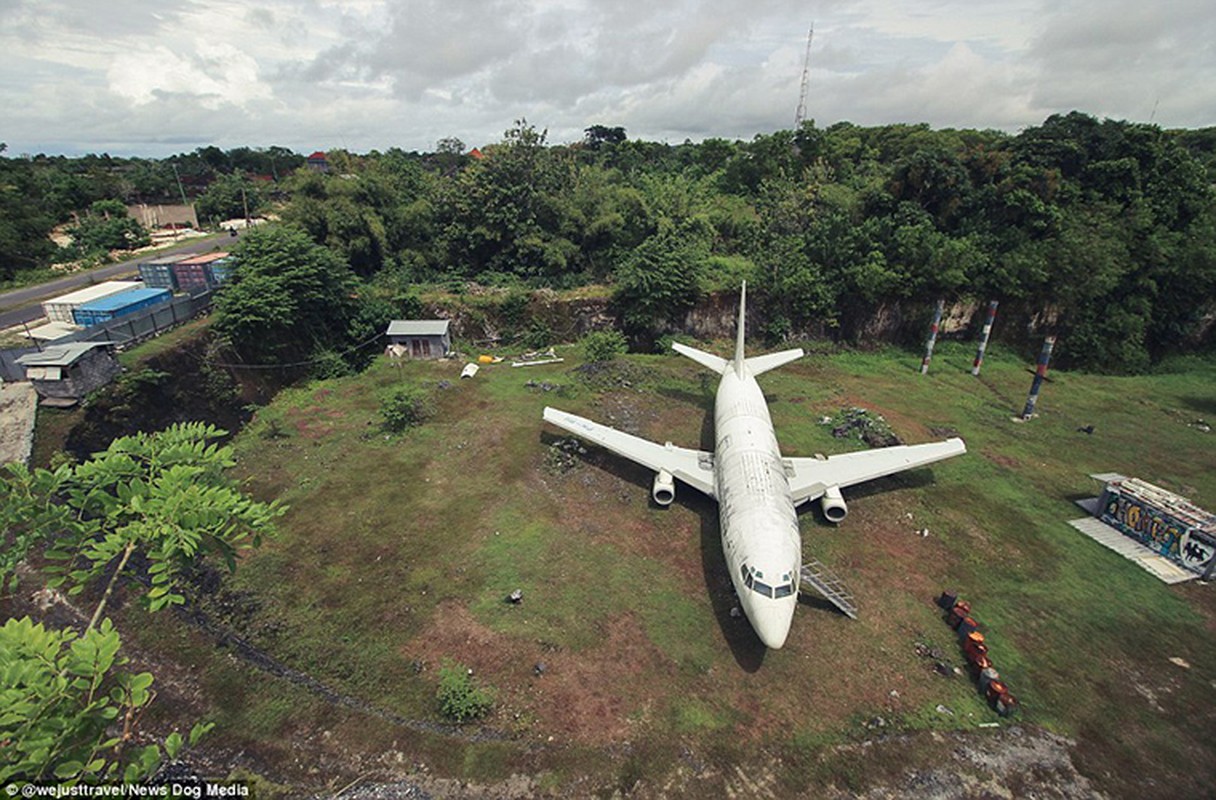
[714,370,803,648]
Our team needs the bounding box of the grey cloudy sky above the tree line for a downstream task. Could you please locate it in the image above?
[0,0,1216,156]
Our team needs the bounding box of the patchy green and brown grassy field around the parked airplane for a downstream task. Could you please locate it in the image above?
[116,343,1216,798]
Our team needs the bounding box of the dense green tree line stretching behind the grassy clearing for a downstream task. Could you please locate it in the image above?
[0,112,1216,370]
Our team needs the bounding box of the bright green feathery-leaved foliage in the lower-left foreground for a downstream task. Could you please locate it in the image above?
[0,423,276,783]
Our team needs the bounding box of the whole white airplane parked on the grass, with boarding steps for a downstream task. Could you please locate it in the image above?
[545,283,967,649]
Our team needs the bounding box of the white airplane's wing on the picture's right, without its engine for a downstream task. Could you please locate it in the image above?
[786,438,967,506]
